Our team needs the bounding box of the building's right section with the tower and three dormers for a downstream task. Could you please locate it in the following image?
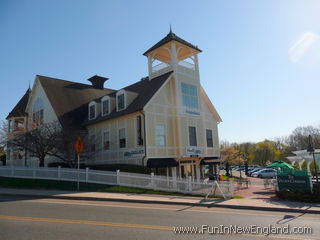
[86,31,221,178]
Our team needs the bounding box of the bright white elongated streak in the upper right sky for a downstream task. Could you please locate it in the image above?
[288,32,320,63]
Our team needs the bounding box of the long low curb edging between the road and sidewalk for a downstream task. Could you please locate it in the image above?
[0,193,320,214]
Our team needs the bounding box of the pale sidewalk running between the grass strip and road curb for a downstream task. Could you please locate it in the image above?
[0,188,320,214]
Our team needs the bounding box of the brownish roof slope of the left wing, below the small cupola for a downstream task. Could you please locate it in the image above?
[37,75,115,128]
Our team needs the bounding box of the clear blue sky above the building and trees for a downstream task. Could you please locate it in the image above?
[0,0,320,142]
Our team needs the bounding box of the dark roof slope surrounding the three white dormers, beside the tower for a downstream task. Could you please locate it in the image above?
[84,71,173,125]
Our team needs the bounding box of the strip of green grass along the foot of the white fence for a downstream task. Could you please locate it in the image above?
[0,177,200,196]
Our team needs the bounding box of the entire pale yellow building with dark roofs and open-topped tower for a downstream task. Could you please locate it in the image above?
[7,31,221,179]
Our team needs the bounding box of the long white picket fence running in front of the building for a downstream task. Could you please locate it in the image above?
[0,166,234,198]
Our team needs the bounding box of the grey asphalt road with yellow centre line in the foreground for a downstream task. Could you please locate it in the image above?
[0,196,320,240]
